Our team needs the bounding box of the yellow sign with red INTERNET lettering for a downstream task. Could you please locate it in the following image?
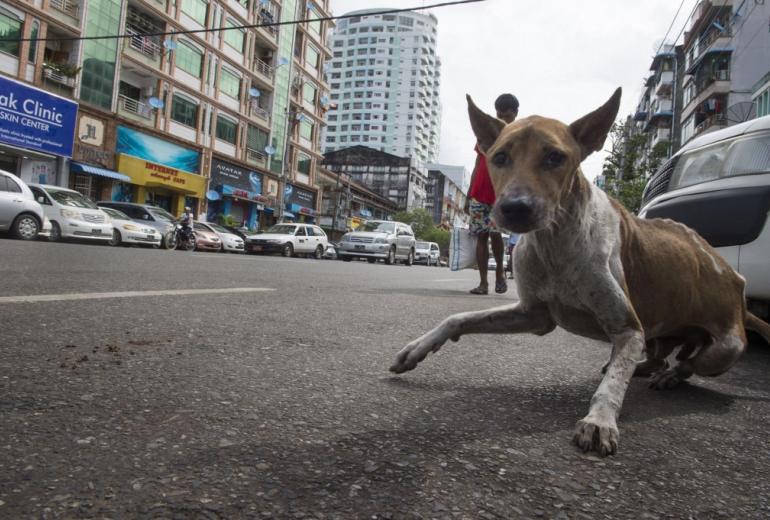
[118,153,206,198]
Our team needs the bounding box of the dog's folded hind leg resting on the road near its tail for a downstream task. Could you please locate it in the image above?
[650,325,747,390]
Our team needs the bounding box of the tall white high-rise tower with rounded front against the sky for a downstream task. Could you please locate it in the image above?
[323,10,441,163]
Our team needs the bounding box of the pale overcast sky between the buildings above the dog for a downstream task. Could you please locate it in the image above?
[331,0,696,178]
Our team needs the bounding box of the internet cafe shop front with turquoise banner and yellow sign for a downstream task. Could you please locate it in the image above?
[112,126,206,215]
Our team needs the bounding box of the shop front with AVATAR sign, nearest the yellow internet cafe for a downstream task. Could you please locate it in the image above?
[206,157,272,229]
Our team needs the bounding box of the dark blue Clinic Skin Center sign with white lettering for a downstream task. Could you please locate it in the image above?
[0,76,78,157]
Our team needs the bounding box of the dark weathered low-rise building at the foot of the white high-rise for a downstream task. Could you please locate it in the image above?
[323,146,428,211]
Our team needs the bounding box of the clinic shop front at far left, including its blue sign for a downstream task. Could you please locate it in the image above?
[0,76,78,184]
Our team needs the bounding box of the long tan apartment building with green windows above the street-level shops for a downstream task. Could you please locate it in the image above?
[0,0,330,227]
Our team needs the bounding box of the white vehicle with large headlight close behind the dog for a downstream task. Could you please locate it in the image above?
[639,116,770,314]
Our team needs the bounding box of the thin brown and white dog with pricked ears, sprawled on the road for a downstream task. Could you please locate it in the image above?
[390,89,770,456]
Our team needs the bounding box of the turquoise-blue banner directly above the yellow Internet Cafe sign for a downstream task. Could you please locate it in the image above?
[116,126,201,173]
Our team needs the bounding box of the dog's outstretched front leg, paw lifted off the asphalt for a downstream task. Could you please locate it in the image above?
[390,302,555,374]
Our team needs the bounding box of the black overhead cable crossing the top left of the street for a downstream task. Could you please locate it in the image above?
[0,0,486,43]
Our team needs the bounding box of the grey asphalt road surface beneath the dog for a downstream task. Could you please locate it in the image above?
[0,239,770,519]
